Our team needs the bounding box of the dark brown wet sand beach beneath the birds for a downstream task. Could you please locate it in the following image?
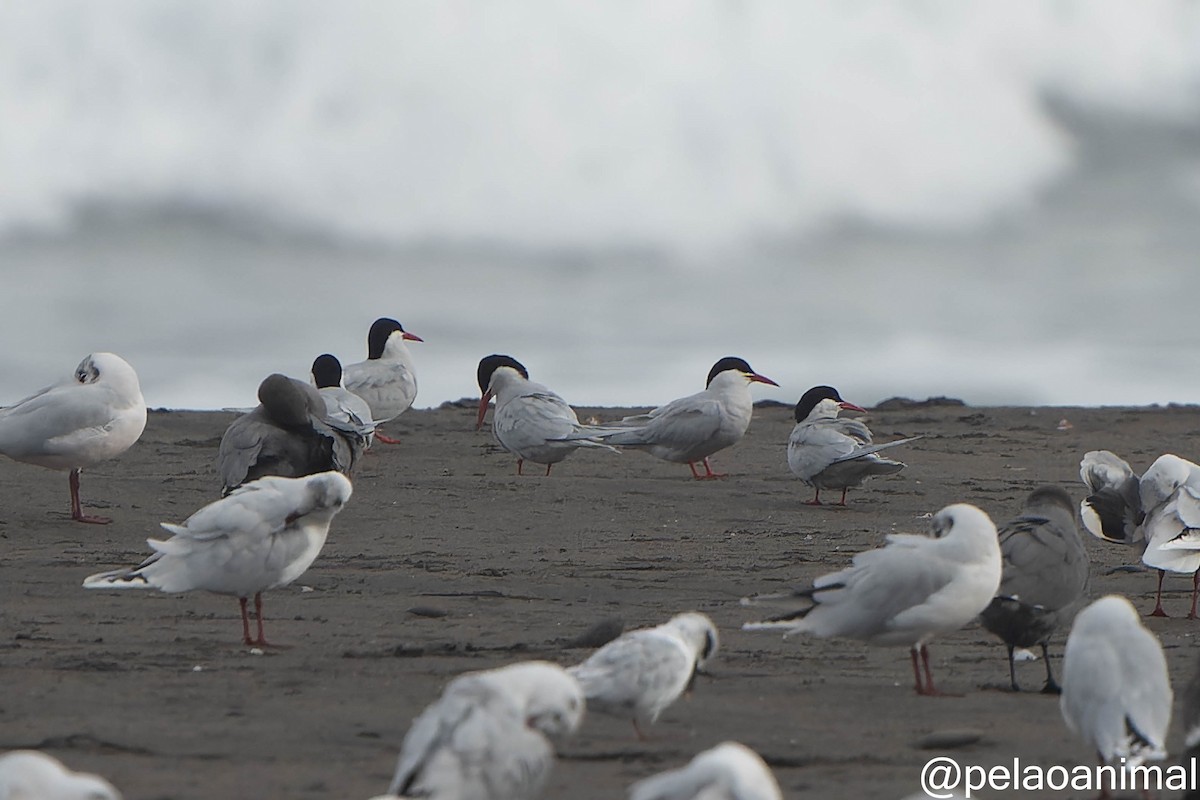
[0,402,1200,800]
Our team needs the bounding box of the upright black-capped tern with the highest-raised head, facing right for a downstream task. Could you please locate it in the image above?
[342,317,425,445]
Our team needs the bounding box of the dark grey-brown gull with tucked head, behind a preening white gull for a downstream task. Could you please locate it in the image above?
[217,373,362,494]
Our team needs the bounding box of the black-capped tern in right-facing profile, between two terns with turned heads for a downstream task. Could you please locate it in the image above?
[565,356,779,480]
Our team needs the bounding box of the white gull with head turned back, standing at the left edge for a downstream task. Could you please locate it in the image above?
[0,353,146,524]
